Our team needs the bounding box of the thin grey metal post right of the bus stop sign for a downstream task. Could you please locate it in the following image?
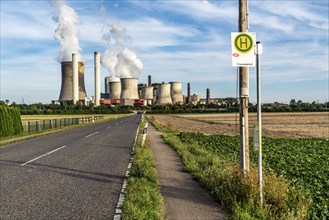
[255,41,263,206]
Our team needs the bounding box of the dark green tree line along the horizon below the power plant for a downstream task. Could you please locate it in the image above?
[0,98,329,115]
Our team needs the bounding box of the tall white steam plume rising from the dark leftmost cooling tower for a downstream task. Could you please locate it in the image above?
[52,0,82,62]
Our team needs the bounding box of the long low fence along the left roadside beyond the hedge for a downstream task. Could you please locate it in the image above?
[22,116,103,133]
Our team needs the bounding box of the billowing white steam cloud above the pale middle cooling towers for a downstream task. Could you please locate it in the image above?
[101,21,143,82]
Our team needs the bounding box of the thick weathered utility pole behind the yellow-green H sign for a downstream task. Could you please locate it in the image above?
[239,0,249,173]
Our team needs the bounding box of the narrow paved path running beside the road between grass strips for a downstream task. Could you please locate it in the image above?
[148,123,228,220]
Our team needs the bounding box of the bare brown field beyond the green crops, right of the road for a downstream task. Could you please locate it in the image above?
[151,112,329,138]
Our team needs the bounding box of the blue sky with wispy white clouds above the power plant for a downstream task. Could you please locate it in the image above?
[0,0,329,104]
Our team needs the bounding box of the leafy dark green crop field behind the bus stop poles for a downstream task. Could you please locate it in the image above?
[180,133,329,219]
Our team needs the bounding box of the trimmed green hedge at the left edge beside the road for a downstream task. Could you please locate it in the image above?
[0,105,23,137]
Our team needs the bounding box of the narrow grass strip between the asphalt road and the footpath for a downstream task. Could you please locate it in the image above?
[122,117,164,220]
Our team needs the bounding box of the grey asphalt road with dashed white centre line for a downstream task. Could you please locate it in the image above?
[0,115,140,220]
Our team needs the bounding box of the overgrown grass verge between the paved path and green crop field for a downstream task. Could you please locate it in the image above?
[149,117,310,220]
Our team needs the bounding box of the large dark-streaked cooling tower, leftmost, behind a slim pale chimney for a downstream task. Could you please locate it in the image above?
[58,61,87,102]
